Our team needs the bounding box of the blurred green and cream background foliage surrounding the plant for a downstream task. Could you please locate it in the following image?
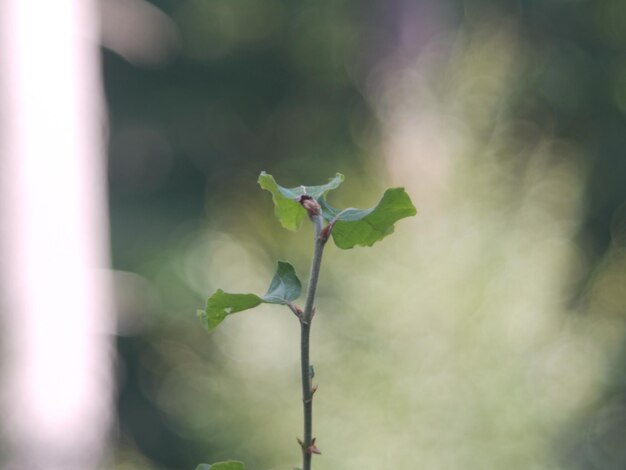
[103,0,626,470]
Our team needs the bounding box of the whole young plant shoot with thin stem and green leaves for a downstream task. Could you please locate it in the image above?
[197,172,417,470]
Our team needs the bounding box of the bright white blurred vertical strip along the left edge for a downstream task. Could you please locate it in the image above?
[0,0,112,470]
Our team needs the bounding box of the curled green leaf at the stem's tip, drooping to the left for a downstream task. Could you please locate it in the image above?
[259,171,344,230]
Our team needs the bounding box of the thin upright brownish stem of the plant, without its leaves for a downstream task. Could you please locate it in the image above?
[300,215,326,470]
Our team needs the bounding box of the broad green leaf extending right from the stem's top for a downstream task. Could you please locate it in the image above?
[320,188,417,250]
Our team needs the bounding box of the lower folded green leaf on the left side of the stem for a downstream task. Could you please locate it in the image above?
[198,261,302,331]
